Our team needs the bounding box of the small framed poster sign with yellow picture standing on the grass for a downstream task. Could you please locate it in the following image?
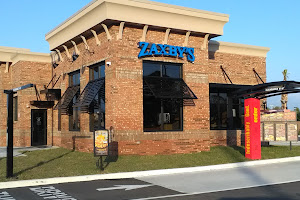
[94,130,109,170]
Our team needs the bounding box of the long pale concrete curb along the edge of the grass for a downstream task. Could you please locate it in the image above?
[0,156,300,189]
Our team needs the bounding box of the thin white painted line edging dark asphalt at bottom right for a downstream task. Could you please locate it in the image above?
[130,180,300,200]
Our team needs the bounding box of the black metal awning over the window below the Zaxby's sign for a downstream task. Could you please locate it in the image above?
[143,77,197,99]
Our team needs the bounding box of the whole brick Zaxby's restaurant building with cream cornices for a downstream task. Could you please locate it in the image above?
[0,0,269,155]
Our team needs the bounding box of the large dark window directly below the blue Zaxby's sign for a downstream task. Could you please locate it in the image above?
[143,62,183,131]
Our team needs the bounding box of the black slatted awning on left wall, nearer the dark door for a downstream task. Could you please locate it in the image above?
[54,85,80,114]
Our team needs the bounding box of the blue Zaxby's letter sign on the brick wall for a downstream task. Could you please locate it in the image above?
[138,42,195,62]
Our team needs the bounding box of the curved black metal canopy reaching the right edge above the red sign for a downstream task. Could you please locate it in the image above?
[232,81,300,99]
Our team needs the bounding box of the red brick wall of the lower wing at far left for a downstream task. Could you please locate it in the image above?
[0,61,51,146]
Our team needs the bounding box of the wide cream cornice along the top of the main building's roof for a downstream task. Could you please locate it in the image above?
[46,0,229,49]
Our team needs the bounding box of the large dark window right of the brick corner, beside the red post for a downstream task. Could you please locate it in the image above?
[209,84,244,130]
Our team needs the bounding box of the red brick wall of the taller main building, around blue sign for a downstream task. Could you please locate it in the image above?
[0,21,265,155]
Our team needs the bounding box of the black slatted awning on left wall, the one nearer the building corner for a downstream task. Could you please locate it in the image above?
[73,78,105,109]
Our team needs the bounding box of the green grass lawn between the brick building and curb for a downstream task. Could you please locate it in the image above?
[0,146,300,181]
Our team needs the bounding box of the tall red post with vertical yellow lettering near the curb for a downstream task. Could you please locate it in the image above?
[244,98,261,159]
